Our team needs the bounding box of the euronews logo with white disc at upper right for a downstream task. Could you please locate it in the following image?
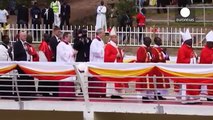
[175,7,195,22]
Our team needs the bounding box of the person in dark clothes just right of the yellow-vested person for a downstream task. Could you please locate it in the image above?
[61,1,70,29]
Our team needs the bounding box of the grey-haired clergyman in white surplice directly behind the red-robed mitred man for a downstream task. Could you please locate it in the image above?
[88,28,106,97]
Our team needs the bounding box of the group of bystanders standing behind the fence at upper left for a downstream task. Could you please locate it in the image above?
[0,0,71,29]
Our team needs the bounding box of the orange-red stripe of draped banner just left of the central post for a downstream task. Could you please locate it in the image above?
[19,65,75,75]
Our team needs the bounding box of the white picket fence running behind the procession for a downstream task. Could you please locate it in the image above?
[1,25,210,48]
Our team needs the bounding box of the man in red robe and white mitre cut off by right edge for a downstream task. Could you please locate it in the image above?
[200,31,213,101]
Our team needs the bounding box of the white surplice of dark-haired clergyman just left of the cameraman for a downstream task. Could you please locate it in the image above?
[56,41,75,63]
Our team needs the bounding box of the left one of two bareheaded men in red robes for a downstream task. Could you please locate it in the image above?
[136,37,154,102]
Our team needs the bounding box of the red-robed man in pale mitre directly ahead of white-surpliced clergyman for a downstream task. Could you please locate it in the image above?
[104,27,128,98]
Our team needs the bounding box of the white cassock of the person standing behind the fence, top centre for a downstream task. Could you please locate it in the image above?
[95,6,107,31]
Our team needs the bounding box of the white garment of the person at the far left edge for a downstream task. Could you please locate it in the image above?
[0,45,11,61]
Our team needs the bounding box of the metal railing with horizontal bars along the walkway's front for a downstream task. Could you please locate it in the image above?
[0,63,213,104]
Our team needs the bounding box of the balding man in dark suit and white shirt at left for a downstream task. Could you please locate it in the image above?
[13,31,35,99]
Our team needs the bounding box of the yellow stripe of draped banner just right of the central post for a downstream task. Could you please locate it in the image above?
[88,67,154,77]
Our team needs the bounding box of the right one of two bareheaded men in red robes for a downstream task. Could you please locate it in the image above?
[152,37,170,100]
